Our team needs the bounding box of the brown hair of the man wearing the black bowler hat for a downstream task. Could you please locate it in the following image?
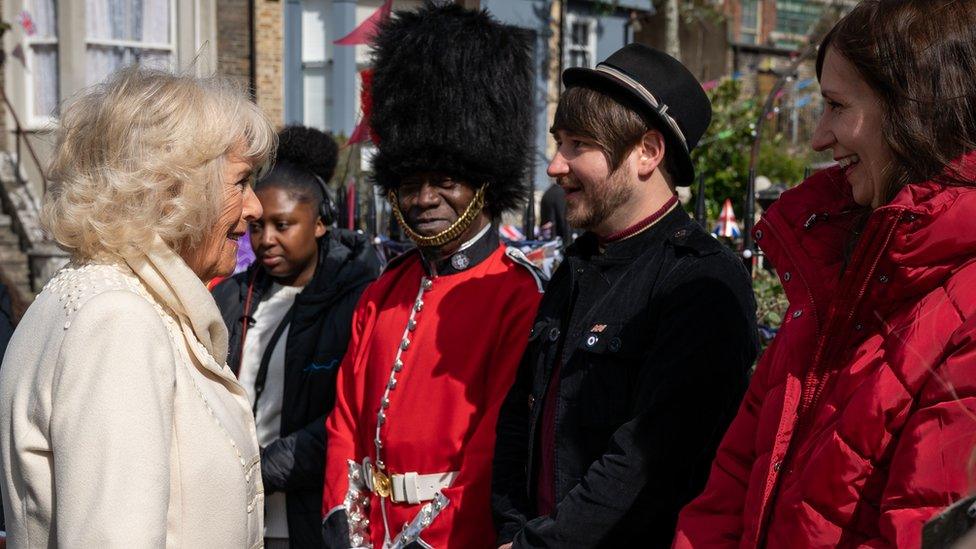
[552,87,671,182]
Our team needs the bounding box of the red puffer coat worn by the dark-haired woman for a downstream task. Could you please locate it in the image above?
[674,153,976,548]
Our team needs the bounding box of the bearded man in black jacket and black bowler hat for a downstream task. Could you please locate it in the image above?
[492,44,757,547]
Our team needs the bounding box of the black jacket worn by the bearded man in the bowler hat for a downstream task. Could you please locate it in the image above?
[492,207,757,548]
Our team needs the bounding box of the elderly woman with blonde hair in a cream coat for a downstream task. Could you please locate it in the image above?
[0,68,276,547]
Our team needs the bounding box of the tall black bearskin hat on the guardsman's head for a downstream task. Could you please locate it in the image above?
[370,3,533,217]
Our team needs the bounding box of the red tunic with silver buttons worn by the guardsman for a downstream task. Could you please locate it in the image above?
[323,246,541,549]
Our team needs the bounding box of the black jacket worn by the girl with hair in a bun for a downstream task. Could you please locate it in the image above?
[213,229,380,548]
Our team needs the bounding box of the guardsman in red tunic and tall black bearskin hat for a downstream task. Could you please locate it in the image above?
[322,4,542,549]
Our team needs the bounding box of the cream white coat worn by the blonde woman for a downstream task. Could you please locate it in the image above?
[0,239,264,549]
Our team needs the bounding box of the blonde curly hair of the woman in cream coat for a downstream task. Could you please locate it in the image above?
[41,66,277,260]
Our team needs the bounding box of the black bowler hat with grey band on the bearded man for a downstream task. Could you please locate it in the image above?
[563,44,712,186]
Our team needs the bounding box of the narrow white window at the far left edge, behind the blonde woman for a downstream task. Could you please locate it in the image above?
[24,0,60,125]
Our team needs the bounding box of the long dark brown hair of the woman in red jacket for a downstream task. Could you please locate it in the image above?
[817,0,976,203]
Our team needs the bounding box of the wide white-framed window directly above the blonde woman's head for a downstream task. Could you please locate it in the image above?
[85,0,176,85]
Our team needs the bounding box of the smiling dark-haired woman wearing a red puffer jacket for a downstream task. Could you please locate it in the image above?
[674,0,976,548]
